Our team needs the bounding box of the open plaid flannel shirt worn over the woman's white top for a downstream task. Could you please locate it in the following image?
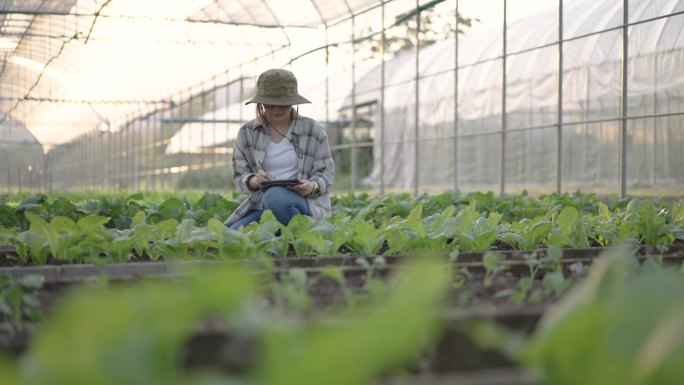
[225,116,335,226]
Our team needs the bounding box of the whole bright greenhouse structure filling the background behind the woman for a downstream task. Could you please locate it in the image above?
[0,0,684,196]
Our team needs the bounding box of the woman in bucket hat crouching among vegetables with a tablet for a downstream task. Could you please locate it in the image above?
[225,69,335,230]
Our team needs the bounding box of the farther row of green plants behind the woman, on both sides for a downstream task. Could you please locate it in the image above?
[0,190,681,230]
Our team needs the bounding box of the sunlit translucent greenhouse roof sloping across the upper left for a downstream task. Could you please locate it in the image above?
[0,0,384,146]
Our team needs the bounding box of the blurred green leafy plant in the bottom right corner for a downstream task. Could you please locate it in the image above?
[468,248,684,385]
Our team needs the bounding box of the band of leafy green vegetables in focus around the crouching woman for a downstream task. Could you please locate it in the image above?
[0,191,684,265]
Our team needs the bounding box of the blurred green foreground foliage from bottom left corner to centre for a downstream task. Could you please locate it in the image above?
[0,258,448,385]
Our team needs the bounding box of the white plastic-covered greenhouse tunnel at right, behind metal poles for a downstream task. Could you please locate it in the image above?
[348,0,684,190]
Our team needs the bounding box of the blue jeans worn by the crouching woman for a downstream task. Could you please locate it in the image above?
[230,186,309,230]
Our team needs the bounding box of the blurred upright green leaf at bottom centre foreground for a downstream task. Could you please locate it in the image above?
[256,258,448,385]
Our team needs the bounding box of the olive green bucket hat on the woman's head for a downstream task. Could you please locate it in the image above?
[245,68,311,106]
